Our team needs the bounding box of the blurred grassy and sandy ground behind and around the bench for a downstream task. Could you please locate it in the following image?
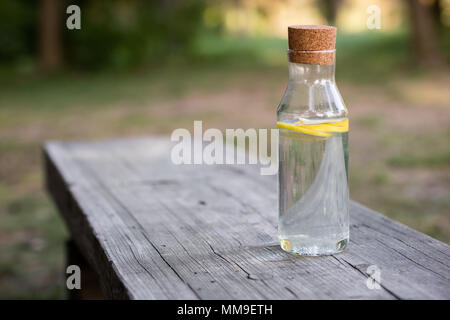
[0,33,450,299]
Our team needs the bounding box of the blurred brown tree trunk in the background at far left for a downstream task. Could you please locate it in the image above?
[38,0,64,72]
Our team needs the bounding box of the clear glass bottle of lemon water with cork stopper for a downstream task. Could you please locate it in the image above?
[277,26,349,256]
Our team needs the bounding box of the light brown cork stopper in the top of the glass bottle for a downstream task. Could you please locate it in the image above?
[288,26,337,65]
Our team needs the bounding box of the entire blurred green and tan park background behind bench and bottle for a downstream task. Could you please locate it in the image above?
[0,0,450,299]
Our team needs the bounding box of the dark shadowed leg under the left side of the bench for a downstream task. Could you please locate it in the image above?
[64,240,104,300]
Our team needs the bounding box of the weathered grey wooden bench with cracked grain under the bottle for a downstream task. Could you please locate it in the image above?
[44,138,450,299]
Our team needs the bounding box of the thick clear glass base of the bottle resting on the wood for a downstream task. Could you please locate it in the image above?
[280,237,349,256]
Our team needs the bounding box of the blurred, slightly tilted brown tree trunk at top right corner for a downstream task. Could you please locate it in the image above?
[407,0,444,65]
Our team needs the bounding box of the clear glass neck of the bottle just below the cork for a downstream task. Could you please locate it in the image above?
[289,62,335,84]
